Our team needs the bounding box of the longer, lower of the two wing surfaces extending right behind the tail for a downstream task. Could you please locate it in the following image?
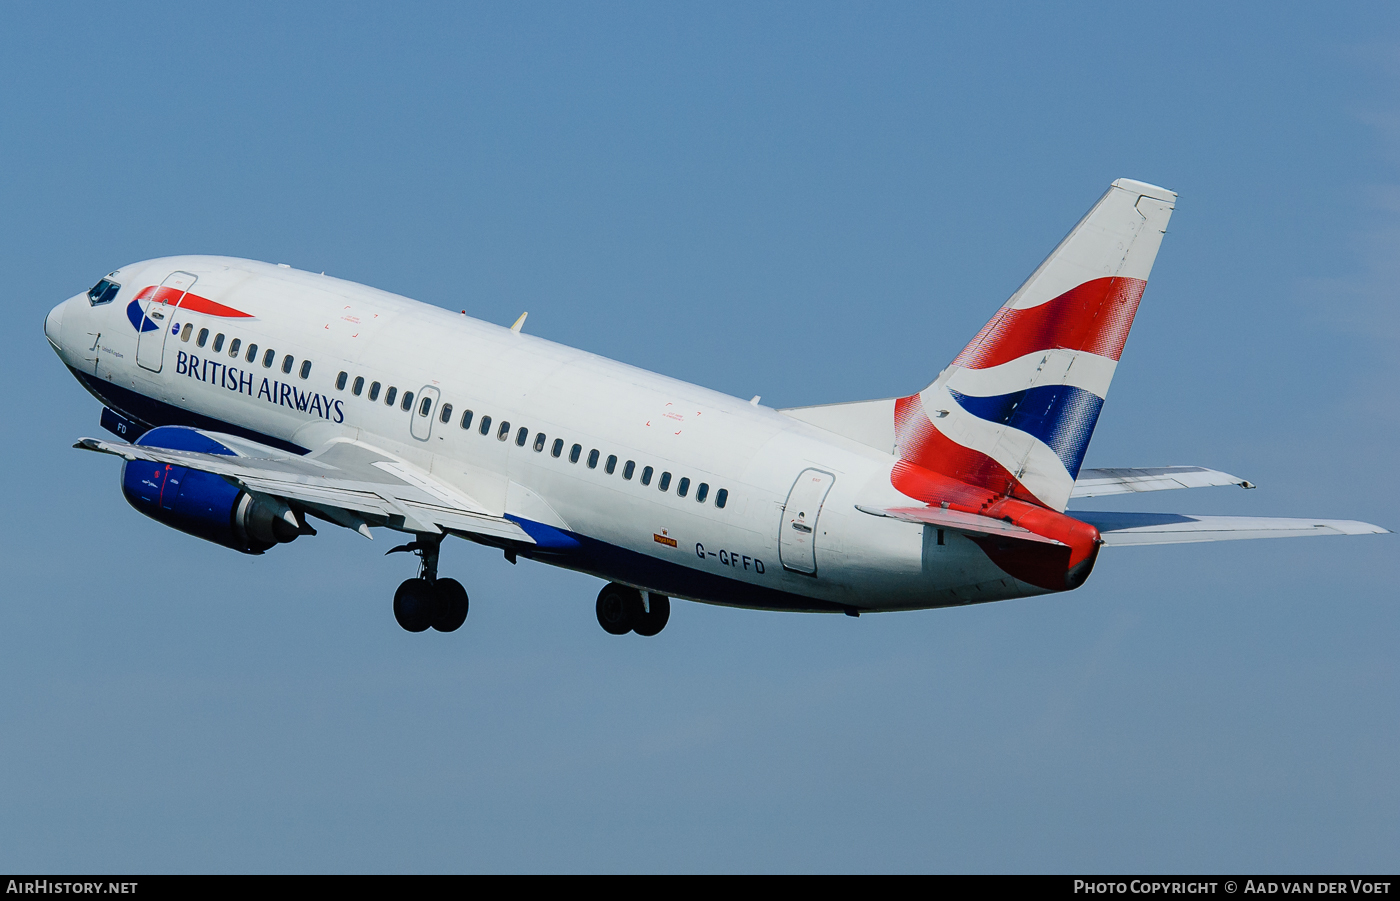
[1065,511,1390,547]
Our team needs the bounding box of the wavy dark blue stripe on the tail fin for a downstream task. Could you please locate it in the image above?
[948,385,1103,478]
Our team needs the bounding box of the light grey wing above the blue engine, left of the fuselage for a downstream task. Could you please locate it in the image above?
[73,432,536,544]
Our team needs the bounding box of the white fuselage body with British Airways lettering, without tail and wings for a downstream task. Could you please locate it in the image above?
[46,256,1044,611]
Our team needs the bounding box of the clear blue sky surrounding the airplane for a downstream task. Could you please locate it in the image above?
[0,3,1400,873]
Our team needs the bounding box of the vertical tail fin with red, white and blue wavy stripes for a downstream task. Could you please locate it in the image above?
[895,179,1176,511]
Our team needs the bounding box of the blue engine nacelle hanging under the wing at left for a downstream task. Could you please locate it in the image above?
[122,425,301,554]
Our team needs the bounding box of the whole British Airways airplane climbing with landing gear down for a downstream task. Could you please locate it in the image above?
[43,179,1387,635]
